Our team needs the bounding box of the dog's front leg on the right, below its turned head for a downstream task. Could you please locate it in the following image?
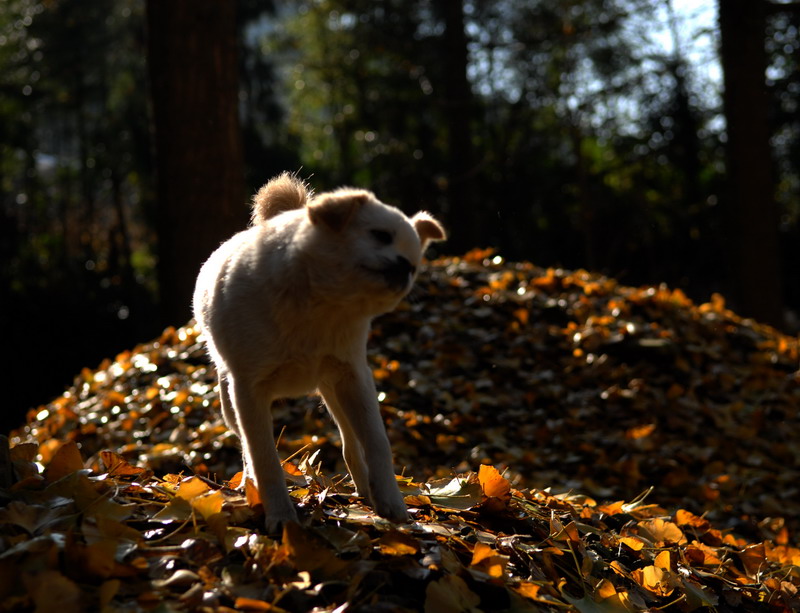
[320,364,408,522]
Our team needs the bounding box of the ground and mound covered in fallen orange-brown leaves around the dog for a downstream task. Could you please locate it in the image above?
[0,252,800,613]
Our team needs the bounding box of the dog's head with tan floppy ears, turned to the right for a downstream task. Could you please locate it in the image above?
[306,188,445,313]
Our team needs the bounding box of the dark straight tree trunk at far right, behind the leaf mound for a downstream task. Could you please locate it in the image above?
[718,0,783,325]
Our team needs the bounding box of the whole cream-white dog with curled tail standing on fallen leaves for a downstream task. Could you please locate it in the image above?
[194,173,445,531]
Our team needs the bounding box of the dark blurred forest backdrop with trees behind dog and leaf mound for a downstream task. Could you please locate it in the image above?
[0,0,800,430]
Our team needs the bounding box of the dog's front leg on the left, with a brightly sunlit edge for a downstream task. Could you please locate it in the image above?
[228,374,297,532]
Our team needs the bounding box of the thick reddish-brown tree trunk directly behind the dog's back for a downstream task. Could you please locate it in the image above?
[147,0,247,325]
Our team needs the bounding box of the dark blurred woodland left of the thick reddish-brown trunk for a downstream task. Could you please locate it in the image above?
[0,0,158,430]
